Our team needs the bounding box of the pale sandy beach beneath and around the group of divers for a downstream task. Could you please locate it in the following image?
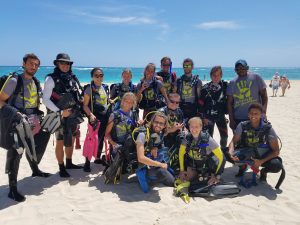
[0,81,300,225]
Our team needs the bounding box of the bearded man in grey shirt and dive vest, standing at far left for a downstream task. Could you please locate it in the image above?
[0,54,50,202]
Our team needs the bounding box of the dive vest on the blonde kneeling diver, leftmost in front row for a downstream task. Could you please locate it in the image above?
[111,109,136,144]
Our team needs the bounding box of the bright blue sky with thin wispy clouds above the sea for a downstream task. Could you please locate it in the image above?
[0,0,300,67]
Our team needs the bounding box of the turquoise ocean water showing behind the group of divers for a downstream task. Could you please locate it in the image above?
[0,66,300,83]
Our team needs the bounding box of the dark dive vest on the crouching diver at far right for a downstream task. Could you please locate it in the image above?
[238,120,272,148]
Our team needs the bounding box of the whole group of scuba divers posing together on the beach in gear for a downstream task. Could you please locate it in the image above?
[0,53,285,202]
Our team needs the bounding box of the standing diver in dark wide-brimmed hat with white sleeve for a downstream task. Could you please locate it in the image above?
[43,53,82,177]
